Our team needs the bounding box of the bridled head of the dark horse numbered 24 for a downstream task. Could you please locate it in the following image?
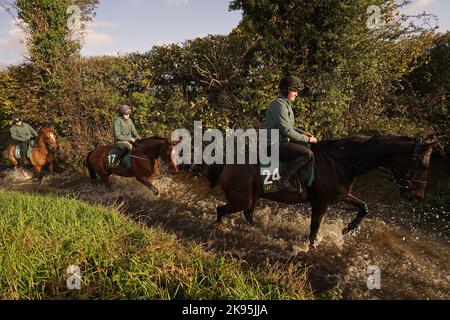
[391,137,439,200]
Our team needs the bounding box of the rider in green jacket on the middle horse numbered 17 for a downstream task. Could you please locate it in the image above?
[113,105,141,166]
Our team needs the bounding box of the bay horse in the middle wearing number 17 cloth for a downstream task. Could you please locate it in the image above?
[86,137,178,195]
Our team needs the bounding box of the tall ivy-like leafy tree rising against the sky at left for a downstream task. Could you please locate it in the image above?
[11,0,98,121]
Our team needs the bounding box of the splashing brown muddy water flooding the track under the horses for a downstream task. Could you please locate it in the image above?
[0,159,450,299]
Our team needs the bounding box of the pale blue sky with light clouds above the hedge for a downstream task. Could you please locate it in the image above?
[0,0,450,65]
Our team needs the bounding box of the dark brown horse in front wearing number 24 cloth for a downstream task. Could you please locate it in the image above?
[207,136,438,248]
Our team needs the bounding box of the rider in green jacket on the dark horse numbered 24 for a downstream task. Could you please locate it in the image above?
[264,75,317,192]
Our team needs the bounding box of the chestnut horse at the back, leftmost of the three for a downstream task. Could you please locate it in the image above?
[3,128,59,179]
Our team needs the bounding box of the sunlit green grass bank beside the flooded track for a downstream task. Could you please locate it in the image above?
[0,190,313,300]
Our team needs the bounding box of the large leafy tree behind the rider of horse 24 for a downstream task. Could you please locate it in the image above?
[230,0,433,136]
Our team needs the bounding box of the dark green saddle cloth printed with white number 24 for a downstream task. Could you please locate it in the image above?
[259,161,314,193]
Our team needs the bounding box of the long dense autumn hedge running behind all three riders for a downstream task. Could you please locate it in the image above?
[0,0,450,168]
